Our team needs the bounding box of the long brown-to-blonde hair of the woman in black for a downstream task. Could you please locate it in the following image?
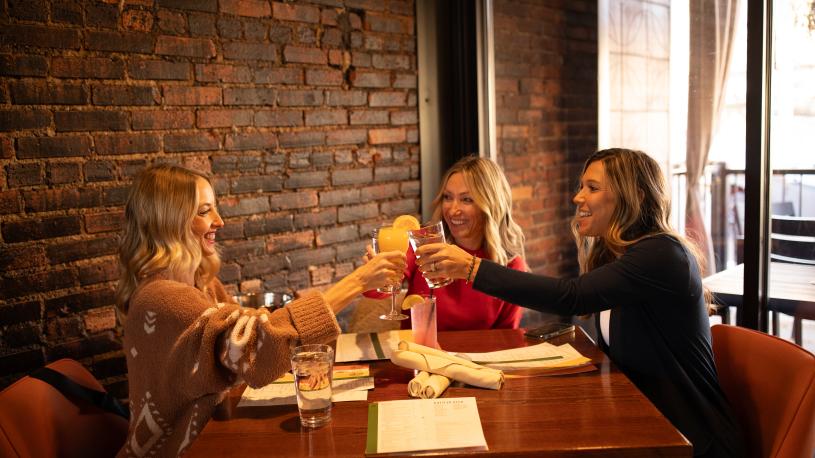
[571,148,712,304]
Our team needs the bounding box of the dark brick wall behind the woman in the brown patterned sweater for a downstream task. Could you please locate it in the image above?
[0,0,420,396]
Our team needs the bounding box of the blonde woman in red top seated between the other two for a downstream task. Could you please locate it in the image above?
[366,156,528,331]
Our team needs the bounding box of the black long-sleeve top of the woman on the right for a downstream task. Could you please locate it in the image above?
[473,235,744,456]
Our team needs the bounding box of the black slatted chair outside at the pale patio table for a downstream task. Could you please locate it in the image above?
[770,215,815,345]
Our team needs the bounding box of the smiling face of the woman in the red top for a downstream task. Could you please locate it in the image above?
[442,173,484,250]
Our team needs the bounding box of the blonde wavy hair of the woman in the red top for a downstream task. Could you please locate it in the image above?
[432,156,524,265]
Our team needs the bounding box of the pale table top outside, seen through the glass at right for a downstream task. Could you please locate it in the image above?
[703,262,815,314]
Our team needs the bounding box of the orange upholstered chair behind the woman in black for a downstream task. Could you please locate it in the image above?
[711,325,815,458]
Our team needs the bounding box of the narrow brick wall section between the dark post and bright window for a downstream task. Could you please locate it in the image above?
[494,0,597,275]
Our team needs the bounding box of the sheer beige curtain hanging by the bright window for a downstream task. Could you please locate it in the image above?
[685,0,738,275]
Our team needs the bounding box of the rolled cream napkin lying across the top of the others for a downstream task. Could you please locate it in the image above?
[391,340,504,394]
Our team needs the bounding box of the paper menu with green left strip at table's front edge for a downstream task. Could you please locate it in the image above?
[365,397,487,454]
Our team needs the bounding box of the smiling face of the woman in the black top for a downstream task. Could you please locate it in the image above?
[573,161,617,237]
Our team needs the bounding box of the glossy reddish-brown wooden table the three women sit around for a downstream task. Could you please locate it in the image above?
[187,328,692,457]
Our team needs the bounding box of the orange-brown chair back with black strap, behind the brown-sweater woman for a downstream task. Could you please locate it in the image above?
[0,359,128,458]
